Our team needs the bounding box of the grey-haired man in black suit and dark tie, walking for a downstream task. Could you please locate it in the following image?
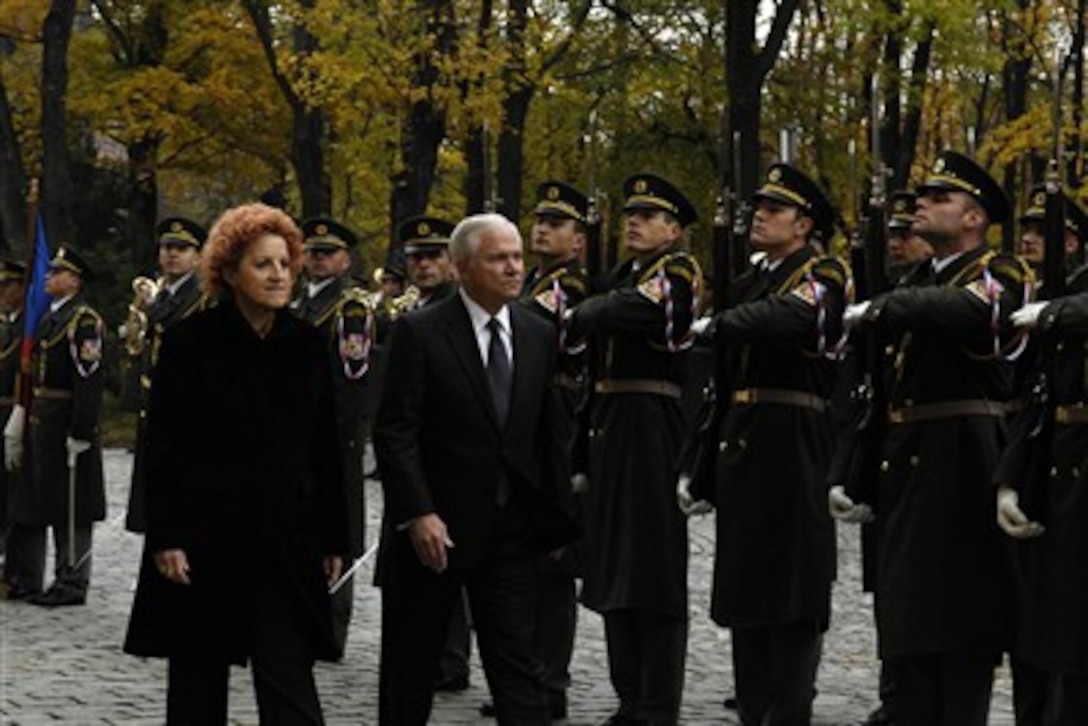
[374,214,574,726]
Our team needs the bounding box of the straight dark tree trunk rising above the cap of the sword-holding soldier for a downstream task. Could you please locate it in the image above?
[41,0,76,248]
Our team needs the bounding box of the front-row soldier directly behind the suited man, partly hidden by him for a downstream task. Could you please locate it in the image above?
[480,181,589,719]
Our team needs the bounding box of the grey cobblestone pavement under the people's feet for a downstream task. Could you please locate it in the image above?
[0,450,1012,726]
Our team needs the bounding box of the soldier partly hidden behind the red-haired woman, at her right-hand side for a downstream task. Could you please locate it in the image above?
[295,217,374,653]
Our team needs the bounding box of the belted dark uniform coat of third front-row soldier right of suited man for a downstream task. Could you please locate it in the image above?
[710,246,846,629]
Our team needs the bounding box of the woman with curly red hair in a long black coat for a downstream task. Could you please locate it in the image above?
[125,204,347,725]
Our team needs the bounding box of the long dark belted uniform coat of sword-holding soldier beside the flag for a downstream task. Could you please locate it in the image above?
[14,295,106,526]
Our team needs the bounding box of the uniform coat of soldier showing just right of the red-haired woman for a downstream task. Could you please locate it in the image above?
[295,278,374,556]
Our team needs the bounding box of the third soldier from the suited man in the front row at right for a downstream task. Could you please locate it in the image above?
[678,163,849,724]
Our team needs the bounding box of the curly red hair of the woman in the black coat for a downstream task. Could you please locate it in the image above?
[200,202,302,298]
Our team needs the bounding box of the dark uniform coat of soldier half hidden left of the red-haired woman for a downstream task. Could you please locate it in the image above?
[125,274,207,532]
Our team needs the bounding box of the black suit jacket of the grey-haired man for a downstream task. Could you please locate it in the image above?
[374,295,577,569]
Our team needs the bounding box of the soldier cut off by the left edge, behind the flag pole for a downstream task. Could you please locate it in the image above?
[0,259,26,596]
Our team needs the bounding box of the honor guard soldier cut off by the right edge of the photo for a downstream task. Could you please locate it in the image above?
[994,197,1088,724]
